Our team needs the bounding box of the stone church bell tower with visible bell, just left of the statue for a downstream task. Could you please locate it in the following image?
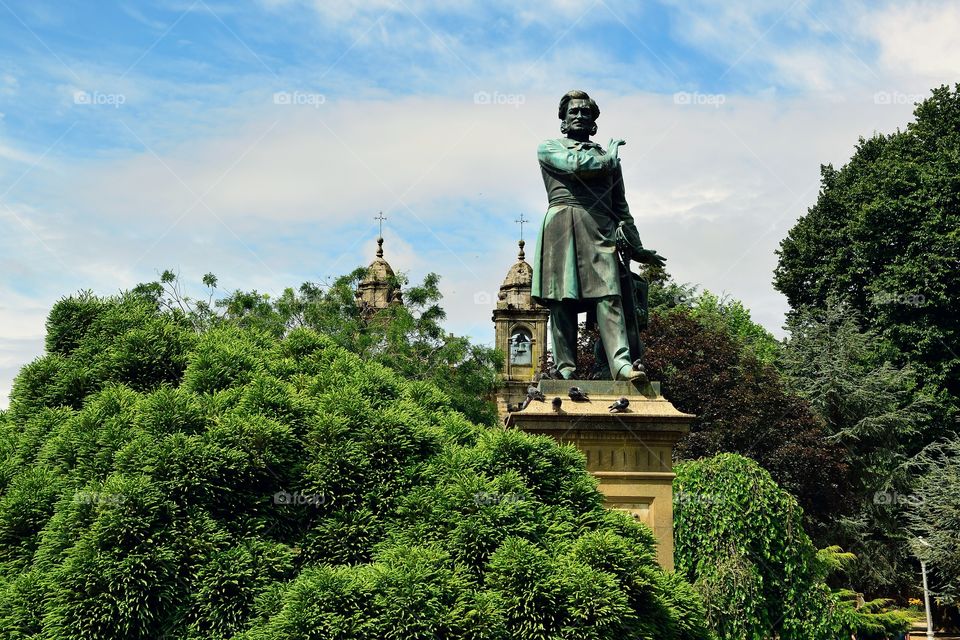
[493,239,550,403]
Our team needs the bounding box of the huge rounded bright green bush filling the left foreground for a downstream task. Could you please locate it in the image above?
[0,287,709,640]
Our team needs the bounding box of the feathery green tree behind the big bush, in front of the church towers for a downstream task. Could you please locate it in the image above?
[134,268,503,424]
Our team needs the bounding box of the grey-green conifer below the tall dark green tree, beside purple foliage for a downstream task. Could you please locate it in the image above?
[782,301,933,593]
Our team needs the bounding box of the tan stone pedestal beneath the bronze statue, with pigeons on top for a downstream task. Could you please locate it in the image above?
[505,380,695,571]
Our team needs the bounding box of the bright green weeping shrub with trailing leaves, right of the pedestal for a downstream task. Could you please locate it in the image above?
[674,454,909,640]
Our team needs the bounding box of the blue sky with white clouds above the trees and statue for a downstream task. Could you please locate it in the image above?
[0,0,960,408]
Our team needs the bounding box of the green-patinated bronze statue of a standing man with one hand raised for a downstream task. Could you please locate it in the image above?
[532,91,664,380]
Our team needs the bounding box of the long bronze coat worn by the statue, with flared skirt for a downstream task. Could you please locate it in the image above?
[531,138,642,306]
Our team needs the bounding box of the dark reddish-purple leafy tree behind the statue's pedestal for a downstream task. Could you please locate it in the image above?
[644,305,849,531]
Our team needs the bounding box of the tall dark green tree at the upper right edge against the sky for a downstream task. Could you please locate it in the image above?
[774,85,960,410]
